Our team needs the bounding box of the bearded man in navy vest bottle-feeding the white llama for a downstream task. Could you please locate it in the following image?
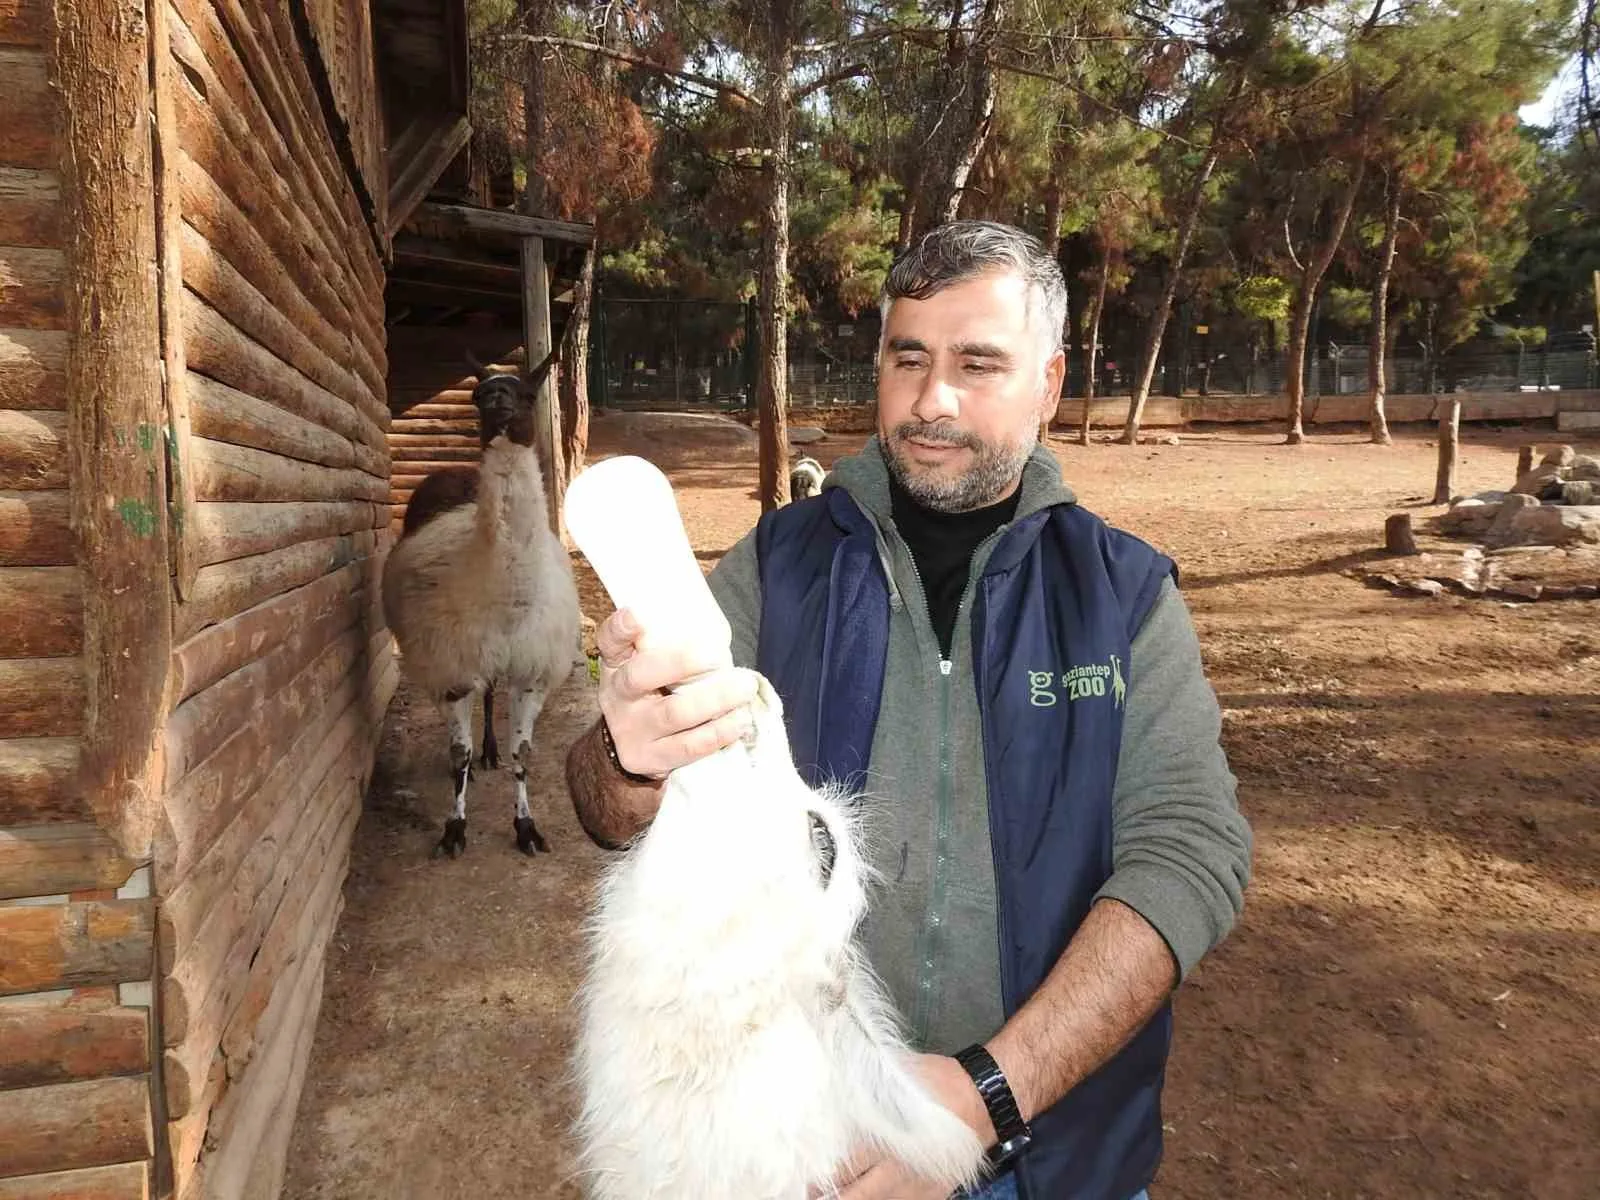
[568,221,1251,1200]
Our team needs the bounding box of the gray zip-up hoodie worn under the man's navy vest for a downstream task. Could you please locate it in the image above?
[710,438,1251,1053]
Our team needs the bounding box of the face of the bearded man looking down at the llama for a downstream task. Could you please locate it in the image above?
[878,272,1066,512]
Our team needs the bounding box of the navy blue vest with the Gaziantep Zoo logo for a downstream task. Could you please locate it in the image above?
[757,488,1176,1200]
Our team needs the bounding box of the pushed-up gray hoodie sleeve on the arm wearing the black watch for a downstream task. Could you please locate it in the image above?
[1096,579,1251,974]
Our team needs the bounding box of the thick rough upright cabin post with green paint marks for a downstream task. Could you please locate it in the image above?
[53,0,173,861]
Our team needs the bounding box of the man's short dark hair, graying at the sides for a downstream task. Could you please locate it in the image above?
[878,221,1067,354]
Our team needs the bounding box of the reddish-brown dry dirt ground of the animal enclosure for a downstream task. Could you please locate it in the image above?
[286,418,1600,1200]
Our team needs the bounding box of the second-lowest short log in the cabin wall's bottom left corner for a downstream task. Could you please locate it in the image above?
[0,1075,154,1176]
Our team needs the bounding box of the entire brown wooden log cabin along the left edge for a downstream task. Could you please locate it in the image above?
[0,0,588,1200]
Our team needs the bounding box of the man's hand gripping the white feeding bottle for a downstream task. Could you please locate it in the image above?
[595,608,757,776]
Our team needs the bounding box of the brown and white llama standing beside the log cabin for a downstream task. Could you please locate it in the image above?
[382,354,579,858]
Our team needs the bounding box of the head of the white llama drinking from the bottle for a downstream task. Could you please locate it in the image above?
[606,680,866,1035]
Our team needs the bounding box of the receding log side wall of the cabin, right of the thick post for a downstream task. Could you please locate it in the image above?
[150,0,398,1200]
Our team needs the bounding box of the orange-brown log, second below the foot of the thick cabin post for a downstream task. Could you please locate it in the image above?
[0,899,155,998]
